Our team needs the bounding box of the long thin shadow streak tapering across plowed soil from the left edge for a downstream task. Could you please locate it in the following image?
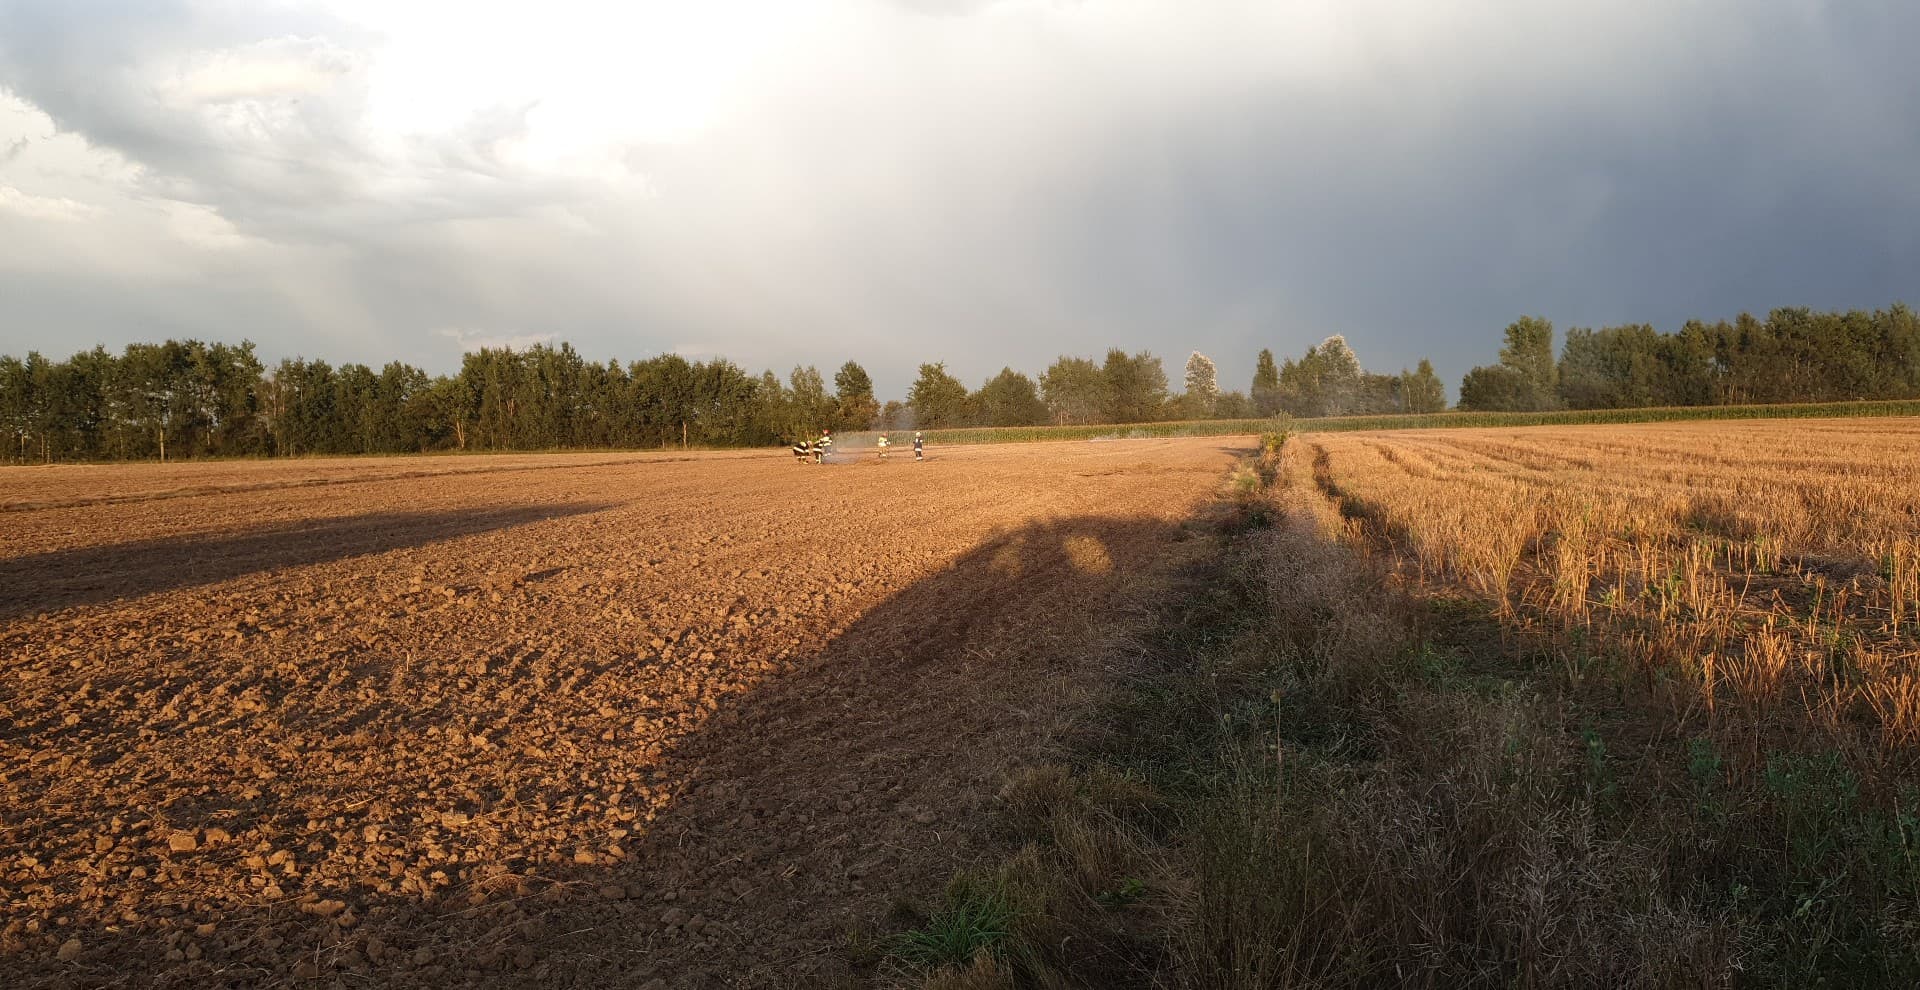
[0,505,607,620]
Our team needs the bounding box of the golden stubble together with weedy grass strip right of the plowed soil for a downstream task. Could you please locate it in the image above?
[906,420,1920,990]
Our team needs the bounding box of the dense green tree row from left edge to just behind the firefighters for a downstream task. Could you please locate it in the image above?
[0,340,877,460]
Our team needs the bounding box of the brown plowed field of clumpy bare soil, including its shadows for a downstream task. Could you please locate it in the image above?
[0,439,1244,986]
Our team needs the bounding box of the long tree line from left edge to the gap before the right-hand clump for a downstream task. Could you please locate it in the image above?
[0,336,1444,462]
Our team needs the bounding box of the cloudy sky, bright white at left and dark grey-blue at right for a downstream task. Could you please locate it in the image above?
[0,0,1920,397]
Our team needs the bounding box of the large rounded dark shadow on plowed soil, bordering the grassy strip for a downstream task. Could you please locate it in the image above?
[530,516,1210,988]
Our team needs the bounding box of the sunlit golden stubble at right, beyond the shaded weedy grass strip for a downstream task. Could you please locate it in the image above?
[1311,420,1920,777]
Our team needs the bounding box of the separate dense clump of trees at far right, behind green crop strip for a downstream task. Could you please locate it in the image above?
[1459,303,1920,413]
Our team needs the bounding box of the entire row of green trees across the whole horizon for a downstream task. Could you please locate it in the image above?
[11,303,1920,462]
